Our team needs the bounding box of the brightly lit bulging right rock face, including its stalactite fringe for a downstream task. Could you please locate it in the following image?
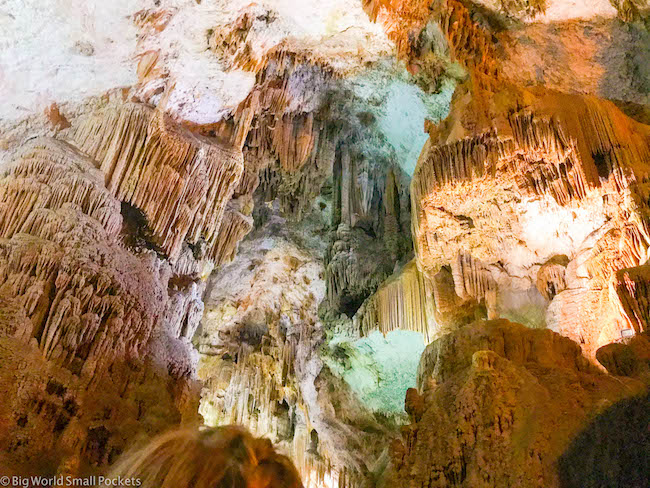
[411,88,649,354]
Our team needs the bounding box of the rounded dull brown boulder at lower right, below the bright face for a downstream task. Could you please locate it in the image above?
[388,320,647,487]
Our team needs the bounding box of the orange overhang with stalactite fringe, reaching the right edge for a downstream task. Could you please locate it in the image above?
[411,94,650,264]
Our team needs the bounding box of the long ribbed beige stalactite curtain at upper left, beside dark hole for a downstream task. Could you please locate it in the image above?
[72,104,243,262]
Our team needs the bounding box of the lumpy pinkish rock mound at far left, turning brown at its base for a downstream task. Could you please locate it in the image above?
[0,139,202,474]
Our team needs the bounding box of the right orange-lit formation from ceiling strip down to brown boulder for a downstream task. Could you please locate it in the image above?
[372,1,650,357]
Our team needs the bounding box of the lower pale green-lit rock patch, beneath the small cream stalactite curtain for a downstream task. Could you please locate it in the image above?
[325,330,425,413]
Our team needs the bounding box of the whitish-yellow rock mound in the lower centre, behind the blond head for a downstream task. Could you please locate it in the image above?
[195,214,390,487]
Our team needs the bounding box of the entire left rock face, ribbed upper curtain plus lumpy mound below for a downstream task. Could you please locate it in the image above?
[0,97,251,472]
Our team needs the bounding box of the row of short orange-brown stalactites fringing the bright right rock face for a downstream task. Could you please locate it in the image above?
[412,113,600,214]
